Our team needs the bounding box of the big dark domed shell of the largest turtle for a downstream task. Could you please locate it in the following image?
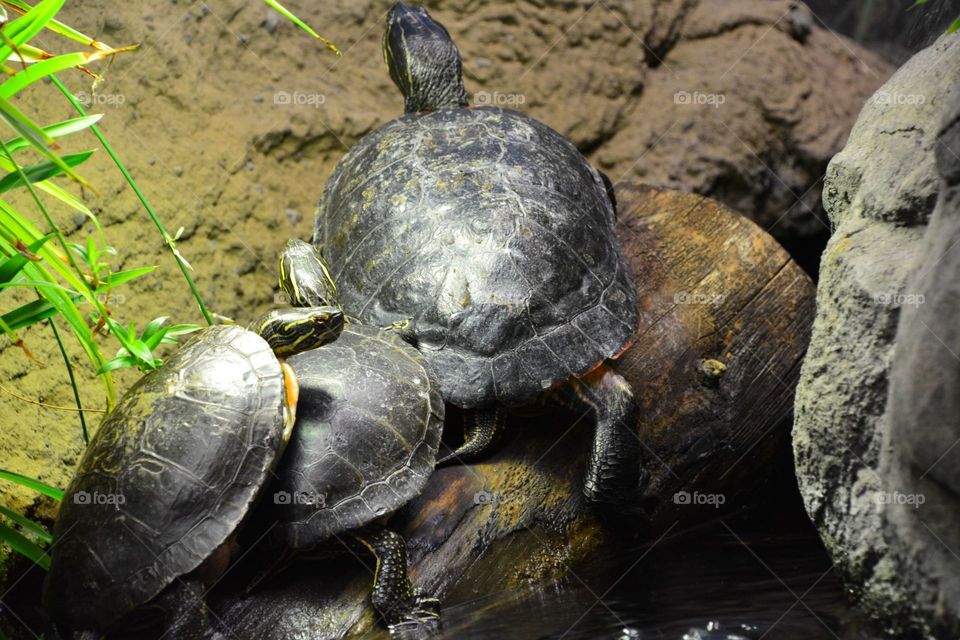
[314,107,639,408]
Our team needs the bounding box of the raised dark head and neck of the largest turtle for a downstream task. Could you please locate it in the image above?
[383,2,467,113]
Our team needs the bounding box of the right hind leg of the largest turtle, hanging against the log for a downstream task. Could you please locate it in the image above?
[564,364,640,505]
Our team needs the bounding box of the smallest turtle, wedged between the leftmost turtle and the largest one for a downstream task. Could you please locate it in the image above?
[264,240,444,627]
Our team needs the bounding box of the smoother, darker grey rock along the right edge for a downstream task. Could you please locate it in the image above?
[874,88,960,638]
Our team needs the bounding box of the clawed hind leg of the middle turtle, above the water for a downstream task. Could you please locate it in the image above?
[352,527,440,628]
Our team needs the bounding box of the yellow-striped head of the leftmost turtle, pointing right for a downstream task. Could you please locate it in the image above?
[248,307,343,358]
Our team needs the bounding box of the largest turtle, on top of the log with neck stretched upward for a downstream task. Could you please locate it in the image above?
[313,3,640,504]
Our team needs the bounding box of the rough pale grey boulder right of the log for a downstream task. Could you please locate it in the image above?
[793,36,960,637]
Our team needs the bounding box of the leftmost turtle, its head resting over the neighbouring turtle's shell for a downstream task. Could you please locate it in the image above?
[42,307,343,639]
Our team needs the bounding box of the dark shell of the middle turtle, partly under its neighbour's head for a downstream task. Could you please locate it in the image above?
[272,324,443,548]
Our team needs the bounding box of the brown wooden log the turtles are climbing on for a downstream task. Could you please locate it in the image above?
[212,185,814,639]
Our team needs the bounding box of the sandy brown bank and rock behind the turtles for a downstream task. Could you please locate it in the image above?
[0,0,890,580]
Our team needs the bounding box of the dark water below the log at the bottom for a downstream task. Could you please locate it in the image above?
[366,522,873,640]
